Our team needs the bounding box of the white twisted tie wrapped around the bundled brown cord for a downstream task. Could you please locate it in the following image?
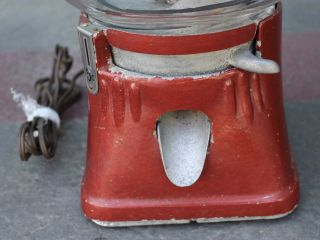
[10,88,61,128]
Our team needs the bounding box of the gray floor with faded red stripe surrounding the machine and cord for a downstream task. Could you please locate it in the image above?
[0,0,320,240]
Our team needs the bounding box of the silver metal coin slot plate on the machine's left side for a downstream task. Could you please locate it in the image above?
[77,23,102,95]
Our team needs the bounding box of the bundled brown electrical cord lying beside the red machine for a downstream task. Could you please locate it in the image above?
[19,45,83,161]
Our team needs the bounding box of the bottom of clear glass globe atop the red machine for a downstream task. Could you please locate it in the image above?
[67,0,279,34]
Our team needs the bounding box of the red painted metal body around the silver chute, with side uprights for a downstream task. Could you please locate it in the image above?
[82,4,299,222]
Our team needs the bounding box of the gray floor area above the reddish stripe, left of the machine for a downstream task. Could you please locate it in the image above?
[0,0,79,52]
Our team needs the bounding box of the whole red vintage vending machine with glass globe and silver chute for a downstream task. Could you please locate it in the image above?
[68,0,299,226]
